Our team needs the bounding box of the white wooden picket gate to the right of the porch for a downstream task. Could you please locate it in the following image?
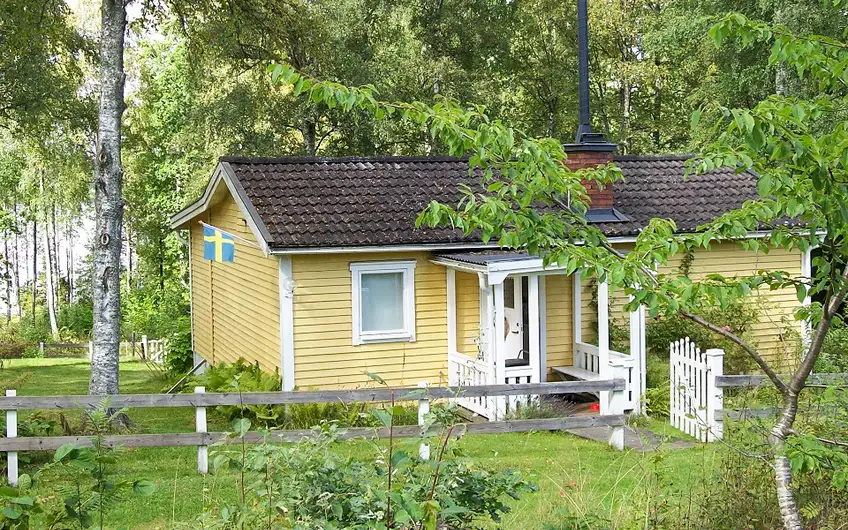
[669,337,724,442]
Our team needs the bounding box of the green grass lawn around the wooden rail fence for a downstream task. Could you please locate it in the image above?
[0,359,715,529]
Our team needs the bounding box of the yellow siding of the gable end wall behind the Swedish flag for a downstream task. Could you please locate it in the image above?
[190,195,280,371]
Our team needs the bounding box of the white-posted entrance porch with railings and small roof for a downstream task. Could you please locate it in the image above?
[432,252,645,420]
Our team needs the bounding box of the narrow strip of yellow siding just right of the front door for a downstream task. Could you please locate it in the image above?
[545,274,574,372]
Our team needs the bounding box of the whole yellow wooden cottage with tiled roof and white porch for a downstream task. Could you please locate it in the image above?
[167,144,810,417]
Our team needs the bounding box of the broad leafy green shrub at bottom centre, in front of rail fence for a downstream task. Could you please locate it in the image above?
[199,407,534,530]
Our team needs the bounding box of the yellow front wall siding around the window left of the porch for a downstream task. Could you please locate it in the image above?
[292,252,450,388]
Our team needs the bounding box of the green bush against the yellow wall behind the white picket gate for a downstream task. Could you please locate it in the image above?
[645,302,760,374]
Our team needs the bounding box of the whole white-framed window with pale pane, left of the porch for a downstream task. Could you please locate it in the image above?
[350,261,415,345]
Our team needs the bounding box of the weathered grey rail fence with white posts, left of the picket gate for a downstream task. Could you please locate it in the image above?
[0,379,626,485]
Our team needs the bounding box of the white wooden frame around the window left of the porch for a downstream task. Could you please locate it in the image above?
[350,261,416,346]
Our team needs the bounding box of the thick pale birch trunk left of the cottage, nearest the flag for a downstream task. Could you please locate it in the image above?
[88,0,127,394]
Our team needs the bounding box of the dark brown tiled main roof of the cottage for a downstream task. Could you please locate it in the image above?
[221,155,756,248]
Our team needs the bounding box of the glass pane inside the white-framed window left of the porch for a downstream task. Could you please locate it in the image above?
[361,272,404,331]
